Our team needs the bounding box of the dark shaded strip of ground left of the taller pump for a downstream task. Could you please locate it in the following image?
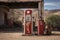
[0,27,24,33]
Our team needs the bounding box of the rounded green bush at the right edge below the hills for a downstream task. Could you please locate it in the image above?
[45,15,60,27]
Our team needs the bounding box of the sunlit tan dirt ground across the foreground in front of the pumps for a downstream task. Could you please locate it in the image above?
[0,32,60,40]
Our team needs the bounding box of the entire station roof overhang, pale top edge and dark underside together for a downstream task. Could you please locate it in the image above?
[0,0,43,8]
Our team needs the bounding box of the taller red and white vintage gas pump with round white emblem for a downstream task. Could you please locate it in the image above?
[24,10,32,34]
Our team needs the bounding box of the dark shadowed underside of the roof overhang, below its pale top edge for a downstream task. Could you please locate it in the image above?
[0,2,38,8]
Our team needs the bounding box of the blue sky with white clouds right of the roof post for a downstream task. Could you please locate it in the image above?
[44,0,60,10]
